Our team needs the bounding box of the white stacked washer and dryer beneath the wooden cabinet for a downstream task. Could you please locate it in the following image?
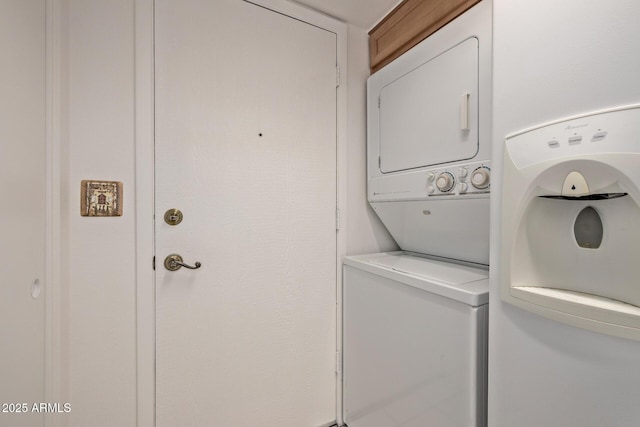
[343,0,492,427]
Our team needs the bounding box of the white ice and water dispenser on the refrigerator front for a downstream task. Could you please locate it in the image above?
[501,105,640,341]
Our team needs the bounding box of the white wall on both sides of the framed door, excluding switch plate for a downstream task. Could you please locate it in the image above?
[54,0,396,427]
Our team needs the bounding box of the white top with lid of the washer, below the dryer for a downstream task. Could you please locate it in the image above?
[344,252,489,307]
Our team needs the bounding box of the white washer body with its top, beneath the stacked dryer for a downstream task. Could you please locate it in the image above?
[343,253,488,427]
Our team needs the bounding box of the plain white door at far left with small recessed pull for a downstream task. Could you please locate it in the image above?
[0,0,46,427]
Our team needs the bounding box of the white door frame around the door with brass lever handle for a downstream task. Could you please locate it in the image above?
[135,0,347,427]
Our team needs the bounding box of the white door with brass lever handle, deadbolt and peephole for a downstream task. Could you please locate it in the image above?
[155,0,337,427]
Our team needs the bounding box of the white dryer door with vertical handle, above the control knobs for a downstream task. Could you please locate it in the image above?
[378,37,478,173]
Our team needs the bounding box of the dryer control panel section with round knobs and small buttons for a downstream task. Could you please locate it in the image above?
[426,161,491,197]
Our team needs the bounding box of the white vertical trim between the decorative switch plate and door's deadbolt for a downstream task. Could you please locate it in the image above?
[135,0,156,427]
